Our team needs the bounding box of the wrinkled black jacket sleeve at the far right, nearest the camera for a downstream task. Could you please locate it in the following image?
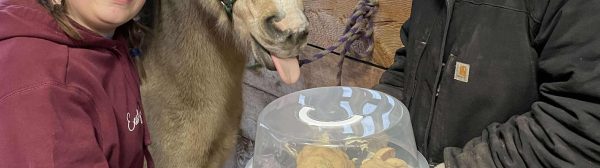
[444,0,600,167]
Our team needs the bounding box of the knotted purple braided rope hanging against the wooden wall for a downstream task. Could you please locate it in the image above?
[299,0,379,85]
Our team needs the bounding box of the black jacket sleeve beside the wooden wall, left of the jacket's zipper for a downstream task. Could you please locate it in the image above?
[373,18,411,100]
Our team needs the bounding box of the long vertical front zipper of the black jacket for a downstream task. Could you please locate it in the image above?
[423,0,454,162]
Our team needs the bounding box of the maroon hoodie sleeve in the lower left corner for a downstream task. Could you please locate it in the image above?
[0,82,108,167]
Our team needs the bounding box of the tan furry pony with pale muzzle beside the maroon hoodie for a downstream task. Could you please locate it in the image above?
[142,0,307,168]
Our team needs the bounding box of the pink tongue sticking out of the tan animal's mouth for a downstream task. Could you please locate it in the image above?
[271,55,300,84]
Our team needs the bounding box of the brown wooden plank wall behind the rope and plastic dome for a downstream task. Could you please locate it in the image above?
[227,0,412,167]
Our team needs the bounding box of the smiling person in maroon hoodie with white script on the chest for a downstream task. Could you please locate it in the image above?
[0,0,152,168]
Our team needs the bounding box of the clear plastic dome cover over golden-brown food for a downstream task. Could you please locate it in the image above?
[249,87,428,168]
